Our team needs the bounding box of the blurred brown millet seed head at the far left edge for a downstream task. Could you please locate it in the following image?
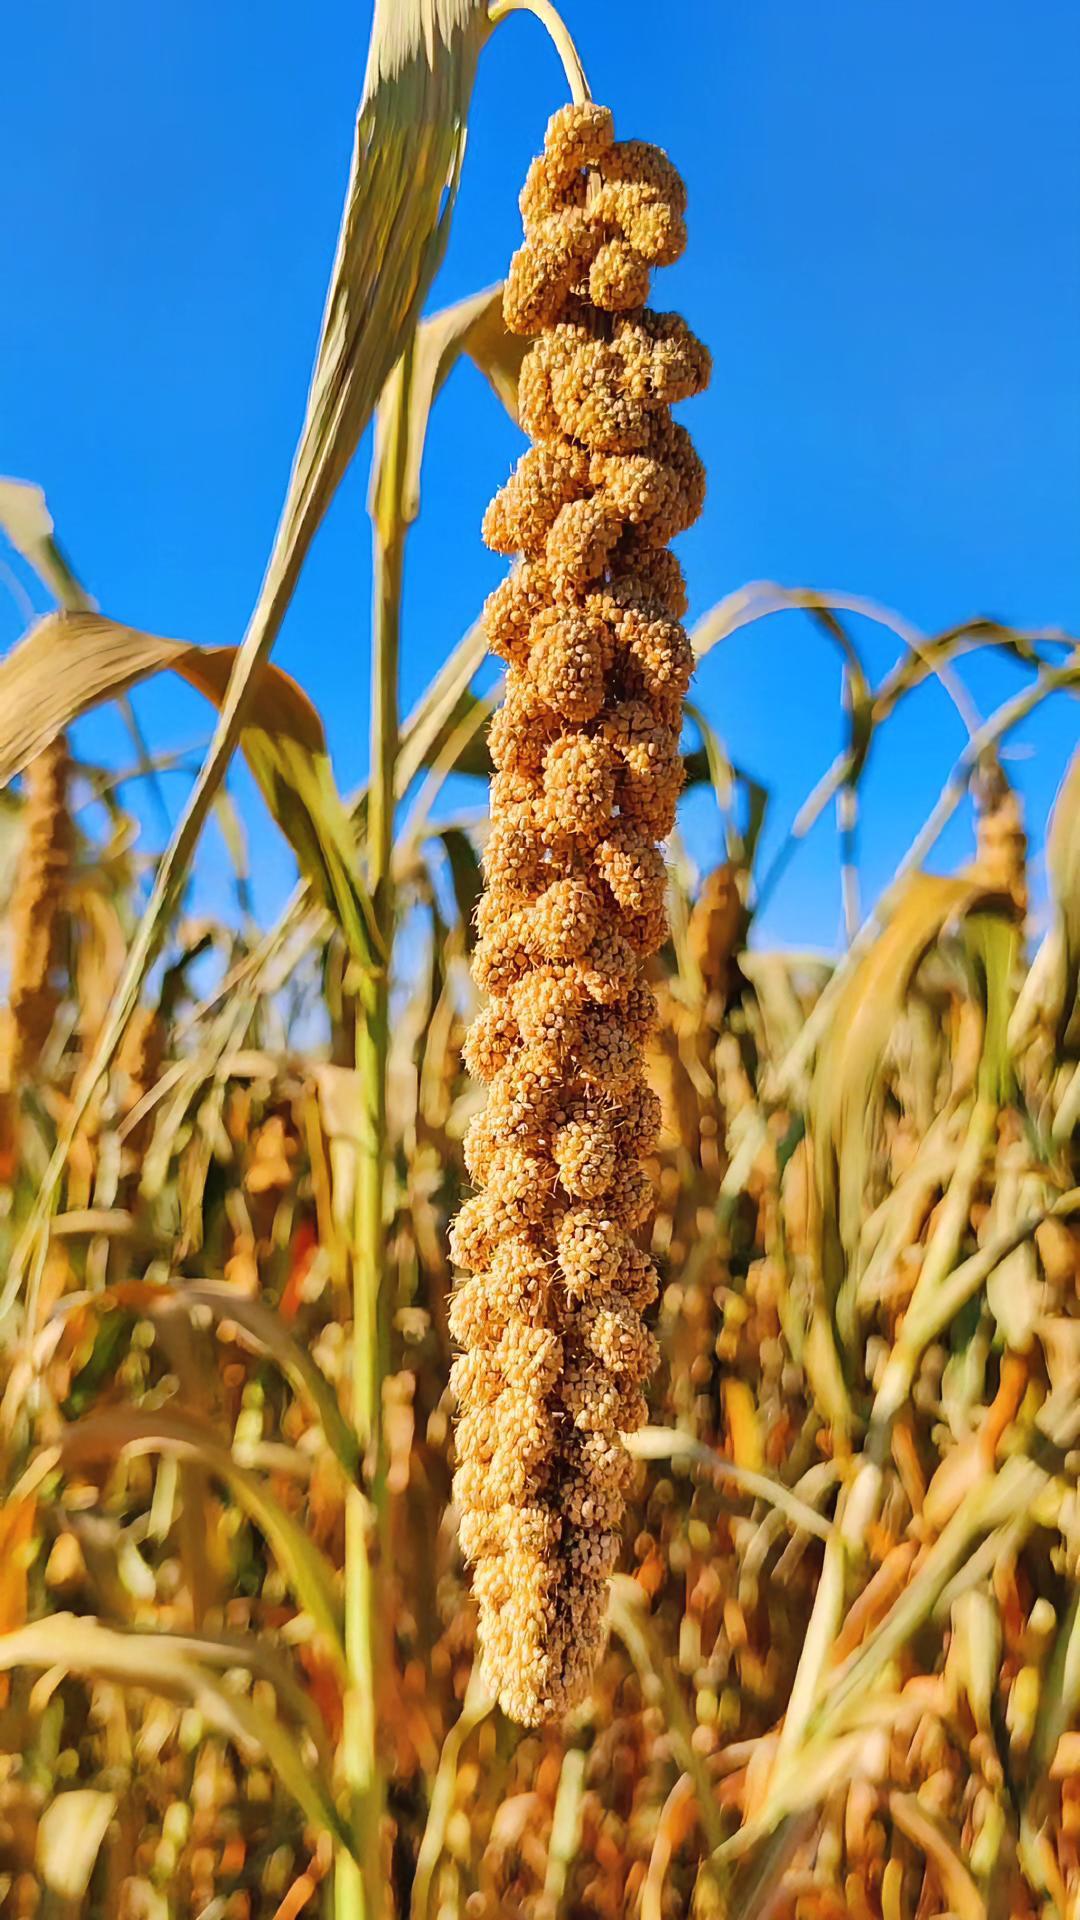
[0,737,73,1085]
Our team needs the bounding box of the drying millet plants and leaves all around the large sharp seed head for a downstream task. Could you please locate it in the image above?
[0,0,1080,1920]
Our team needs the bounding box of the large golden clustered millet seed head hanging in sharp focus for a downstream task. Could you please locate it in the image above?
[450,104,709,1724]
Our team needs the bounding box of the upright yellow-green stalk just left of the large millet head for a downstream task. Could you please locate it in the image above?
[334,346,413,1920]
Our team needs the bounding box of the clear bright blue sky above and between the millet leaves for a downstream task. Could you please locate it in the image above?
[0,0,1080,945]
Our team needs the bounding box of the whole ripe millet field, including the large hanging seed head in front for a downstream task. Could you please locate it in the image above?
[0,0,1080,1920]
